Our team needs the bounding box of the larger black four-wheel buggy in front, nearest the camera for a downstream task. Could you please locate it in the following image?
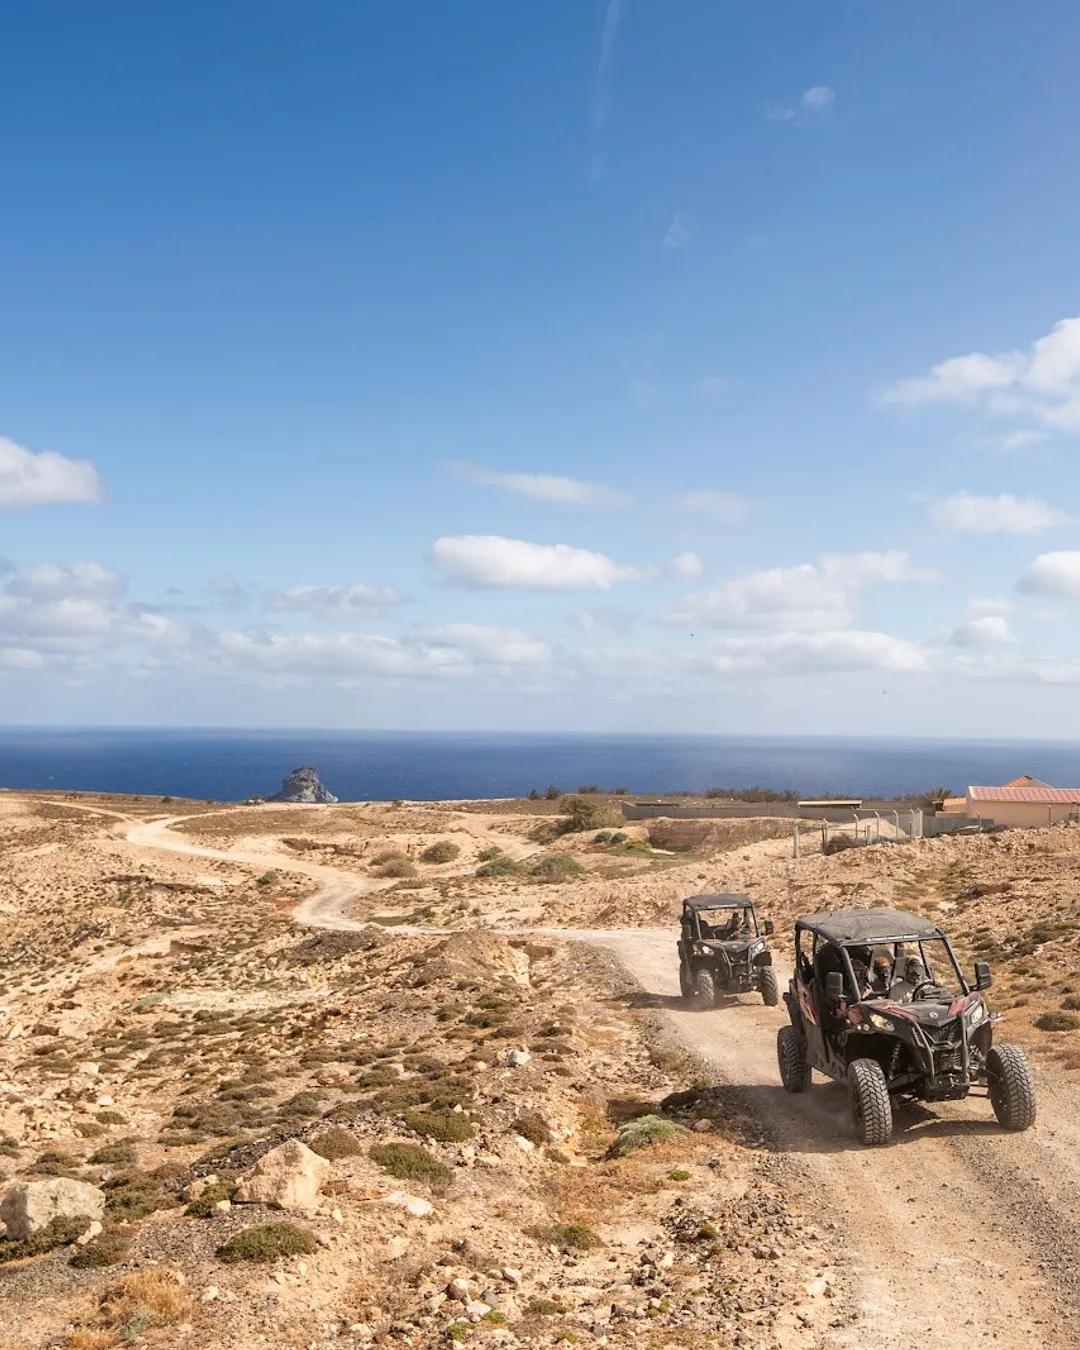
[776,910,1035,1143]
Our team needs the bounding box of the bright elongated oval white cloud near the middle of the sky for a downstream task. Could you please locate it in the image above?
[431,535,656,591]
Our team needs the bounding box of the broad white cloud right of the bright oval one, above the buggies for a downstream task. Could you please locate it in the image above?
[666,552,934,633]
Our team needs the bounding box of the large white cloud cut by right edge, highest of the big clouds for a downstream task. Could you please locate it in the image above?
[879,317,1080,450]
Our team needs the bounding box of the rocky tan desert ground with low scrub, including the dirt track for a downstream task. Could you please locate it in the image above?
[0,792,1080,1350]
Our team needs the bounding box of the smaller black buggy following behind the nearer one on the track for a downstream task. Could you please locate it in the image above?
[679,895,780,1008]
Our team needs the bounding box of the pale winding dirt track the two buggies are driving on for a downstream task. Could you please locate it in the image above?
[126,819,1080,1350]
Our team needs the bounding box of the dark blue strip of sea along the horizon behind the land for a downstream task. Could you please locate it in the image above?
[0,728,1080,802]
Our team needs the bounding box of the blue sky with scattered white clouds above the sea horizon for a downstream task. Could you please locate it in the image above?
[0,0,1080,736]
